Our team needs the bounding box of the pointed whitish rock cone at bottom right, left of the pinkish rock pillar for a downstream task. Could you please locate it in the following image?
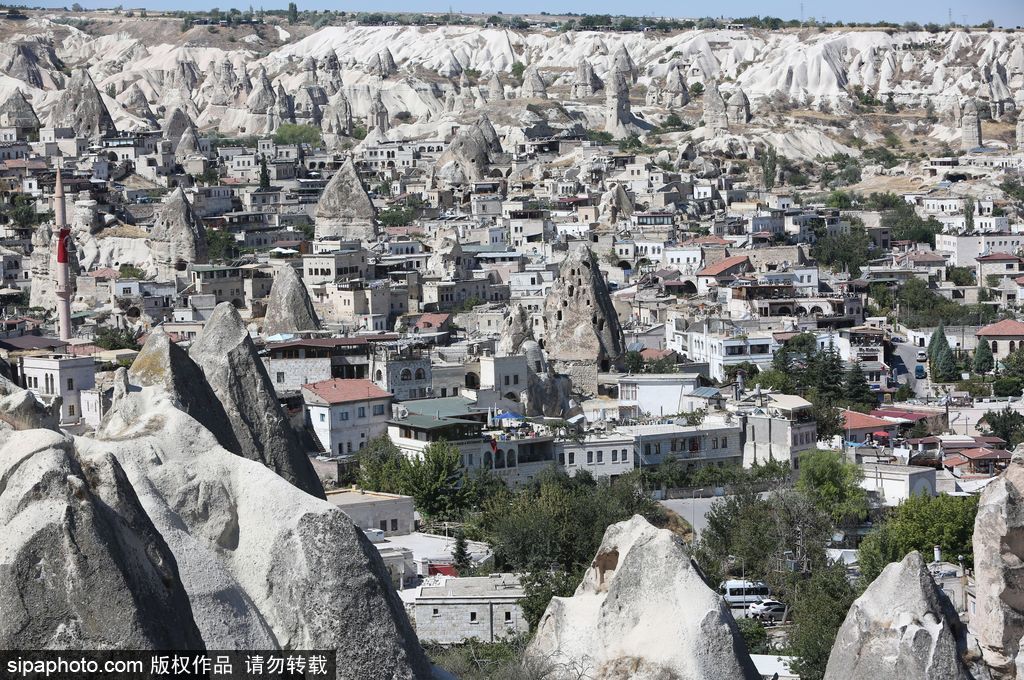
[824,552,972,680]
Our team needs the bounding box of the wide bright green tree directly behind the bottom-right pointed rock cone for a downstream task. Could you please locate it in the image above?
[859,494,978,587]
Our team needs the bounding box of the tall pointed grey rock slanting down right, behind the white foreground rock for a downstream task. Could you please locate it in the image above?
[188,302,324,498]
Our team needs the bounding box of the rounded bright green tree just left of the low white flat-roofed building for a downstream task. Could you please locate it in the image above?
[797,450,868,524]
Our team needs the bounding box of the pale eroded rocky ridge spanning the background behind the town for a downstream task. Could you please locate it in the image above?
[0,13,1024,158]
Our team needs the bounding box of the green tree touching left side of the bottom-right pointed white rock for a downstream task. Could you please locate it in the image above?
[790,563,856,680]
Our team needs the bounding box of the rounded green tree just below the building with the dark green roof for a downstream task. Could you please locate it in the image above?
[402,440,469,518]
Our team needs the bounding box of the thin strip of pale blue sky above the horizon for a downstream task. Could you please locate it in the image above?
[44,0,1024,27]
